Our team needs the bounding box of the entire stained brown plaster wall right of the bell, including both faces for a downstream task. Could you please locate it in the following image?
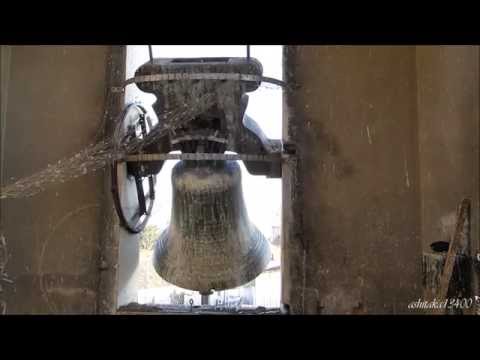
[283,46,479,313]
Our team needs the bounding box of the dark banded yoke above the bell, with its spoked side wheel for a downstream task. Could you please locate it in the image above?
[112,52,283,233]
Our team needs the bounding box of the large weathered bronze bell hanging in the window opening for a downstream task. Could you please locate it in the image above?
[153,160,271,294]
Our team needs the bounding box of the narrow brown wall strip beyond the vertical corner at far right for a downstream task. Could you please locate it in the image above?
[417,46,480,250]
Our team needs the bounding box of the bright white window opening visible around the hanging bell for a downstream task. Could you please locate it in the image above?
[118,45,283,316]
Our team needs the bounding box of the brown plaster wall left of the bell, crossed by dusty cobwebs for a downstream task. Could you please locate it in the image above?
[2,46,110,314]
